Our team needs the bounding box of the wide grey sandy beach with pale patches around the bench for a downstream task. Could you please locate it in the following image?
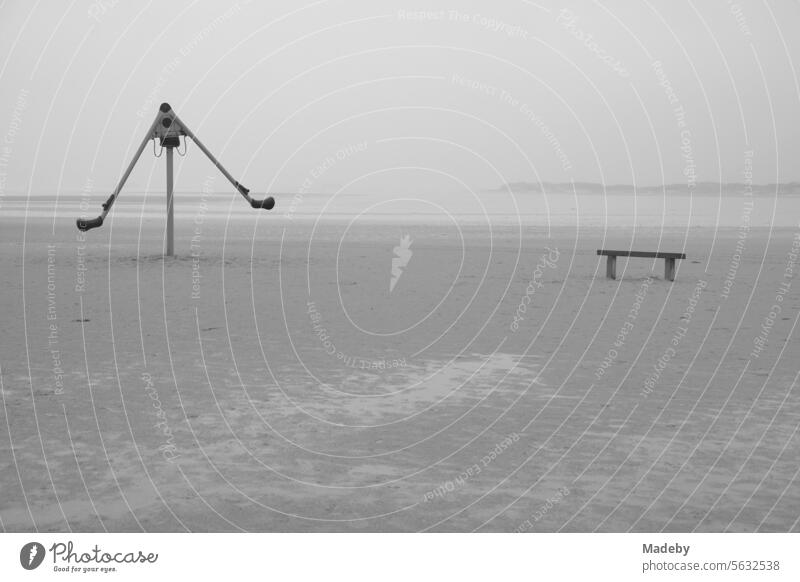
[0,197,800,531]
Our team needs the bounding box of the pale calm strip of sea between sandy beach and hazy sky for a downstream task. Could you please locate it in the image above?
[0,191,800,227]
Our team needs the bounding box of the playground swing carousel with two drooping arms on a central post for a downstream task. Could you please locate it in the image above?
[77,103,275,256]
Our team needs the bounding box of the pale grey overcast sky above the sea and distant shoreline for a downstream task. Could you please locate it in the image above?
[0,0,800,194]
